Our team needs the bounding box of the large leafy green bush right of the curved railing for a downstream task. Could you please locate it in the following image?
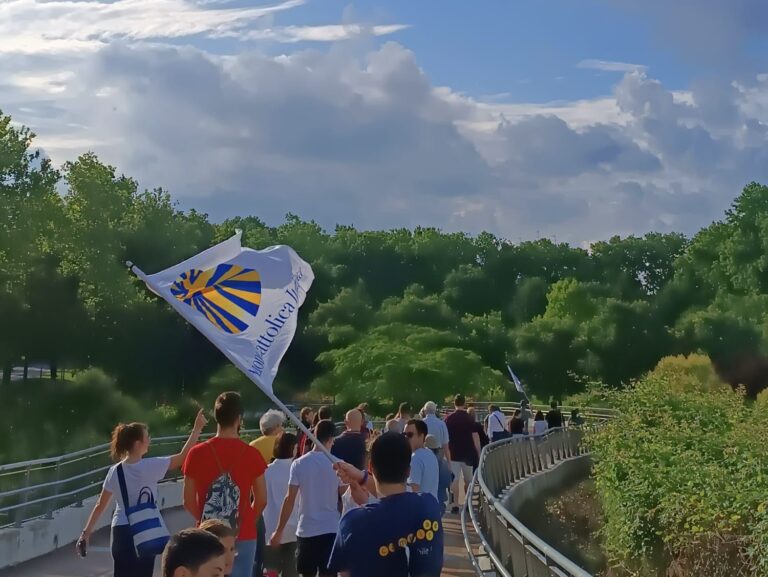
[588,356,768,577]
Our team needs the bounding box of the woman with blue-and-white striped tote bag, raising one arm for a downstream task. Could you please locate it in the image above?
[77,409,207,577]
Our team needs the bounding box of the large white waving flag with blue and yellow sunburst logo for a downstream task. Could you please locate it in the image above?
[132,231,315,396]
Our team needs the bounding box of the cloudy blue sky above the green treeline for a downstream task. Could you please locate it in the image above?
[0,0,768,245]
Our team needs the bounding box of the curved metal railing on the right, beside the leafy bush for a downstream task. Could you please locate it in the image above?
[461,427,591,577]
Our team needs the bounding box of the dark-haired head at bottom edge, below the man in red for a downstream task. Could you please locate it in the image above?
[162,529,225,577]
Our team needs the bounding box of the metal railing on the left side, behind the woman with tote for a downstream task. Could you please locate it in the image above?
[0,430,260,528]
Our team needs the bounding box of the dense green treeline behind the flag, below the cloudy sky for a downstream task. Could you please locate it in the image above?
[0,108,768,414]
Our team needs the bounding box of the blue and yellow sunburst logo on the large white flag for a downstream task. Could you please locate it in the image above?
[171,264,261,335]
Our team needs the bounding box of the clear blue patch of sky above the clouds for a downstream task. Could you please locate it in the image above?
[248,0,699,102]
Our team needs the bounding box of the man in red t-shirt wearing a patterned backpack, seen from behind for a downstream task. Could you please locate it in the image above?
[182,392,267,577]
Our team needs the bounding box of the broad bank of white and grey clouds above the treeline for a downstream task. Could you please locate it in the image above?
[0,0,768,243]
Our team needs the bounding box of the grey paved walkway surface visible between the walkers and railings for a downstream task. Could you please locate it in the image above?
[0,509,474,577]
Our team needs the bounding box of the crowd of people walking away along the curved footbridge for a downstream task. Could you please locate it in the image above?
[77,392,580,577]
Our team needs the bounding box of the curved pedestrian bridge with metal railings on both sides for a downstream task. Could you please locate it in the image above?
[0,407,610,577]
